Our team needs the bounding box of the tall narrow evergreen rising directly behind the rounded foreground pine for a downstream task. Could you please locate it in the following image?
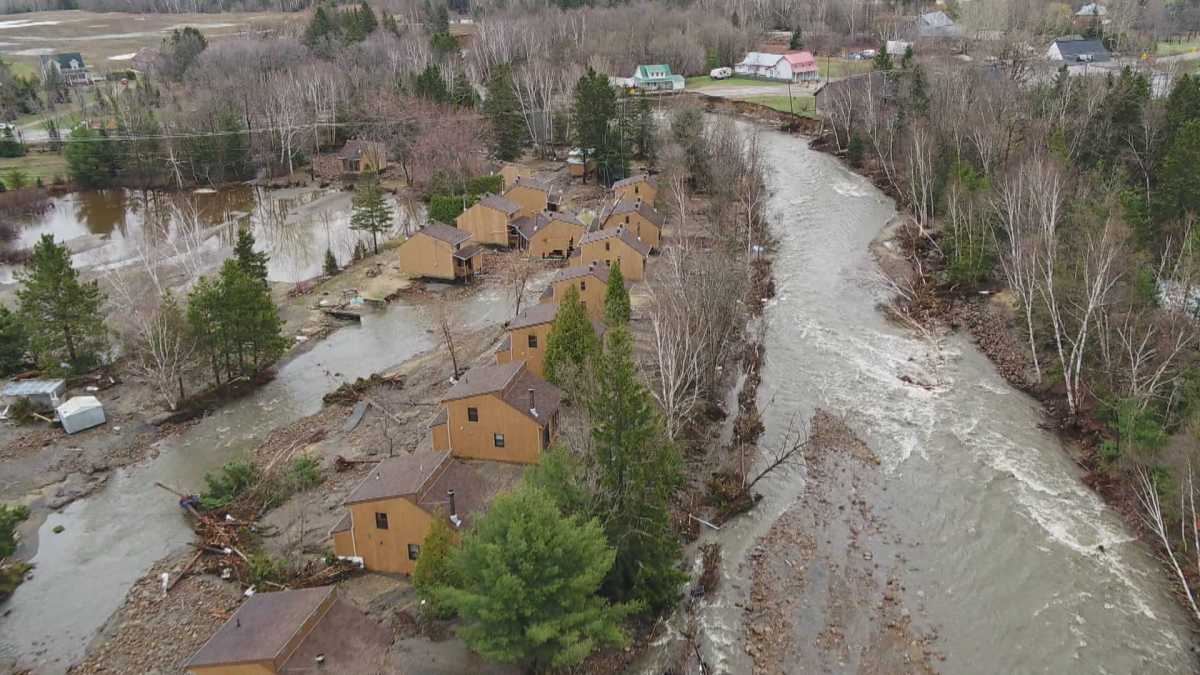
[588,325,686,611]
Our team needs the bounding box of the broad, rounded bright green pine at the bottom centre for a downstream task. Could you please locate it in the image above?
[442,488,632,671]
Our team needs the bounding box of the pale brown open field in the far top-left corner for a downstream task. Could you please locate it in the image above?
[0,10,292,73]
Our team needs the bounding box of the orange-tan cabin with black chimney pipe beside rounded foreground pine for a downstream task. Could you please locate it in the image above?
[330,450,486,574]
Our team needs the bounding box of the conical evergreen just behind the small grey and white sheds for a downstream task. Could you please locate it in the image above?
[17,234,108,372]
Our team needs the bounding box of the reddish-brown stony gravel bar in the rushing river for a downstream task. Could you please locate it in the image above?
[745,411,938,675]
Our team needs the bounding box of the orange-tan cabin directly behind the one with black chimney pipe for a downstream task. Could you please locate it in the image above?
[432,360,563,464]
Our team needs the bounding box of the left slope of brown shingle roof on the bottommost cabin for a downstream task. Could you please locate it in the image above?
[187,586,334,668]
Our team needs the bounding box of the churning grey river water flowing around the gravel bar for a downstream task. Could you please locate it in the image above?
[662,127,1194,674]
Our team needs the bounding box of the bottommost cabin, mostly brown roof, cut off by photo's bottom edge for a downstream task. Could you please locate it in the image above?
[184,586,392,675]
